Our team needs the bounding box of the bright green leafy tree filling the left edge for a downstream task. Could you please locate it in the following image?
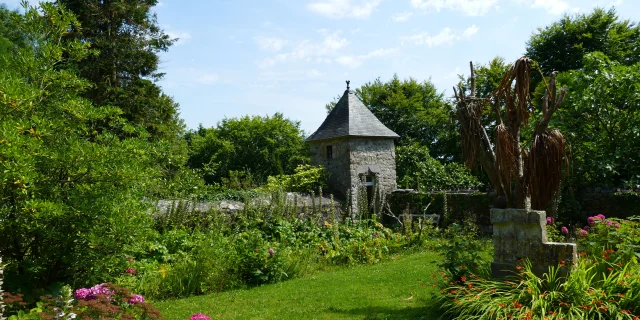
[0,2,158,290]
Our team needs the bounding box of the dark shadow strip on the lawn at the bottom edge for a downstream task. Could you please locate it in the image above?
[327,303,443,320]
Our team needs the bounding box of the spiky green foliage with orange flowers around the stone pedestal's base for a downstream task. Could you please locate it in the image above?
[439,215,640,319]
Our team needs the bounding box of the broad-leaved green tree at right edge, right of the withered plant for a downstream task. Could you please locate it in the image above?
[553,52,640,187]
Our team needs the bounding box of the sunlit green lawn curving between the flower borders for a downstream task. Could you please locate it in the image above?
[155,252,439,319]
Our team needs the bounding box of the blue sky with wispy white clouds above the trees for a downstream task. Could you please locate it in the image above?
[7,0,640,135]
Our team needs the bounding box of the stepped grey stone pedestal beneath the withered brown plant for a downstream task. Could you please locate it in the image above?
[491,209,578,278]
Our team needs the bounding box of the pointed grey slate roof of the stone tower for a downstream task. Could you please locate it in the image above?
[307,88,400,141]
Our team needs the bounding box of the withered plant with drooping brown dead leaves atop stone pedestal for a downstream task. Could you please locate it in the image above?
[453,57,568,210]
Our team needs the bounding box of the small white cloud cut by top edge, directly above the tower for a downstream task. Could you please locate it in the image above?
[307,0,382,19]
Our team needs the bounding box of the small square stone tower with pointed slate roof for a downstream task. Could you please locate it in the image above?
[306,81,399,213]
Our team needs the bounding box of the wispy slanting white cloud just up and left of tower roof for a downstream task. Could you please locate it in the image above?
[260,29,349,68]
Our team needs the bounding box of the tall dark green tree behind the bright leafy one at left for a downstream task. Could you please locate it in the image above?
[56,0,181,139]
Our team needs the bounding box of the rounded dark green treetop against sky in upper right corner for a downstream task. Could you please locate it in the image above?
[526,8,640,74]
